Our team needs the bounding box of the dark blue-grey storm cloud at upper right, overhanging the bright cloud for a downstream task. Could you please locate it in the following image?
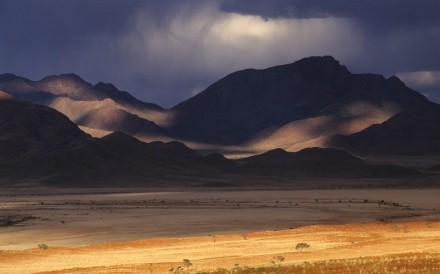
[219,0,440,69]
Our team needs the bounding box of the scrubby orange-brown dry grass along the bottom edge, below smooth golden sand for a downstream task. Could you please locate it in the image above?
[24,253,440,274]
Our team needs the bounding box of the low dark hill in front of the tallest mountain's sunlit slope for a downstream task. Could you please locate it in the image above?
[234,148,419,178]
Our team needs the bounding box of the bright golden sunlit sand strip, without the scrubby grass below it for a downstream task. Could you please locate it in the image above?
[0,221,440,273]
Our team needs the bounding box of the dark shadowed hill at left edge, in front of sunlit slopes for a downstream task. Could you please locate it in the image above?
[0,94,90,182]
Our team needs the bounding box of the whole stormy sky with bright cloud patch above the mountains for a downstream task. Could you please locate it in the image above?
[0,0,440,107]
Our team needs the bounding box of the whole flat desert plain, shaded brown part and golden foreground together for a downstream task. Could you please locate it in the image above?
[0,186,440,273]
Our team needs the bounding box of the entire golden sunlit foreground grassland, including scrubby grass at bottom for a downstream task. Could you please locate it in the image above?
[0,221,440,273]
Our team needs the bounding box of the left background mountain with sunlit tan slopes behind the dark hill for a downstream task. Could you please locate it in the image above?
[0,74,168,136]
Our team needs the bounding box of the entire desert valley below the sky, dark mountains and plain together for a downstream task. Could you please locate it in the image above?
[0,56,440,274]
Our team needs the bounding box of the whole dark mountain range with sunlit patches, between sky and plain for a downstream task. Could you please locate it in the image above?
[0,56,440,186]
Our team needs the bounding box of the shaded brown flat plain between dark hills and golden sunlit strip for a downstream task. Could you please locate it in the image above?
[0,189,440,250]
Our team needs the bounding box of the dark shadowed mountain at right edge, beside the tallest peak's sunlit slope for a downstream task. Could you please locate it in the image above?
[330,109,440,155]
